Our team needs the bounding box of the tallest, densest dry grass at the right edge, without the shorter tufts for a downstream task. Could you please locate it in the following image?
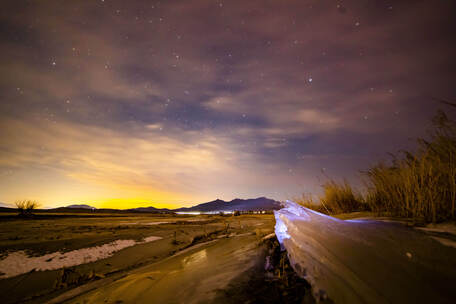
[365,112,456,222]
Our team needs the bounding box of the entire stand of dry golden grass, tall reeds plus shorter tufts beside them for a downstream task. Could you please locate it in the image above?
[297,111,456,222]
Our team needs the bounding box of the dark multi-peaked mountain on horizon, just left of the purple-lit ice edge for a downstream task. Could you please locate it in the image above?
[173,197,281,212]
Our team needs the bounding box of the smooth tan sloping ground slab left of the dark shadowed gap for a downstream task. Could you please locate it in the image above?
[64,234,264,303]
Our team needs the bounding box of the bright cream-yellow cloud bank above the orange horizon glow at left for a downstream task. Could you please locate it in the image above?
[0,120,228,190]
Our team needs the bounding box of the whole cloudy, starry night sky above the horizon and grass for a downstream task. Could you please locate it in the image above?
[0,0,456,208]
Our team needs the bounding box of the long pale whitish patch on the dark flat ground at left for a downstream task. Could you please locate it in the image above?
[0,236,161,279]
